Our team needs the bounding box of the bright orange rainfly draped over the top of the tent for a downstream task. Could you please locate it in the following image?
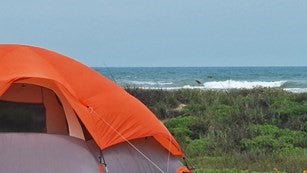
[0,44,183,156]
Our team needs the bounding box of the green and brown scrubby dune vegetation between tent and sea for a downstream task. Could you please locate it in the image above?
[126,87,307,173]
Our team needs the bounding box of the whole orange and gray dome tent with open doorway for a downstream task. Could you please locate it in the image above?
[0,44,191,173]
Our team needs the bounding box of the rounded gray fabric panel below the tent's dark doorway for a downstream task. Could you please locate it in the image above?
[0,133,99,173]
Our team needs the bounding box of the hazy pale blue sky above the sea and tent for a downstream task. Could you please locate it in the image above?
[0,0,307,67]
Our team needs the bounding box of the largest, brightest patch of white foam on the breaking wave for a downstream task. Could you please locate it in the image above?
[204,80,287,89]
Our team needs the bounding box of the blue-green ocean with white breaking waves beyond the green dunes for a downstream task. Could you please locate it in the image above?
[94,67,307,93]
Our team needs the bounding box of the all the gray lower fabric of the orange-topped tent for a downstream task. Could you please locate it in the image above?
[0,133,182,173]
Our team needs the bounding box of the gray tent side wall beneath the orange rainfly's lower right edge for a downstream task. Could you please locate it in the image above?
[88,137,183,173]
